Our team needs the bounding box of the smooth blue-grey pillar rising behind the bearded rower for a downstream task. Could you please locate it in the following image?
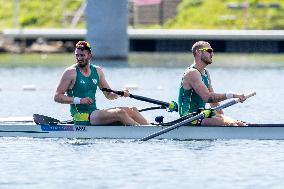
[86,0,128,59]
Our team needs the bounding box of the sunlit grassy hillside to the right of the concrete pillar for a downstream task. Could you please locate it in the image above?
[164,0,284,29]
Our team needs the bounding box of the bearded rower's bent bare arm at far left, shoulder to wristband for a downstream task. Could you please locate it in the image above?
[54,69,75,104]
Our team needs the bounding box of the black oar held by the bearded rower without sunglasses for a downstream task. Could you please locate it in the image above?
[101,88,178,112]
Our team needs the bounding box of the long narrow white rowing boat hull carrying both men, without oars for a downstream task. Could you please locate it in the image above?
[0,121,284,140]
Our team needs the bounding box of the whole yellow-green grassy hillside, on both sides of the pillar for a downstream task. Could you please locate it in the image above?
[0,0,284,30]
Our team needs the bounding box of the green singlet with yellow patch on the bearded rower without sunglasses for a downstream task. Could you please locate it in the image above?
[67,64,100,125]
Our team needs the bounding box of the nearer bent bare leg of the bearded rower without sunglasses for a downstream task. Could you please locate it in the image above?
[90,108,139,125]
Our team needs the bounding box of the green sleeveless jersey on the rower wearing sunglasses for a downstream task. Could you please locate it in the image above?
[178,66,209,116]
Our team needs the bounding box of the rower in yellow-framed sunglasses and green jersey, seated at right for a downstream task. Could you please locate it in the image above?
[179,41,246,126]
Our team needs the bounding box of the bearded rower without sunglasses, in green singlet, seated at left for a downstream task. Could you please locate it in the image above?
[54,41,148,125]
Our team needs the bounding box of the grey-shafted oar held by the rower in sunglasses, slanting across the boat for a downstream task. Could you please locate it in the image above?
[139,92,256,141]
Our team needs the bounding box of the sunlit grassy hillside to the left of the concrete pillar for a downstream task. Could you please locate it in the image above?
[0,0,84,29]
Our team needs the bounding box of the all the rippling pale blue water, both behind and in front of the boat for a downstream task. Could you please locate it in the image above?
[0,53,284,189]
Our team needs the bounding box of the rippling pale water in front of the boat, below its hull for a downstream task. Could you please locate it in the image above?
[0,138,284,189]
